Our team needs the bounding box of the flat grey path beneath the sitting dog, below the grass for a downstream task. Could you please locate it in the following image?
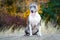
[0,34,60,40]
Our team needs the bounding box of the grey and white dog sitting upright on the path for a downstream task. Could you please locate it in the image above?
[25,3,41,36]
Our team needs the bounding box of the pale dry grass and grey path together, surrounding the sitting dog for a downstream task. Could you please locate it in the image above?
[0,22,60,40]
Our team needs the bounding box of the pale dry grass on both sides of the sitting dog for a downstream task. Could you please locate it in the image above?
[0,21,58,36]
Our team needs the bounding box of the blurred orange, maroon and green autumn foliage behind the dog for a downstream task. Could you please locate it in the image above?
[0,0,60,32]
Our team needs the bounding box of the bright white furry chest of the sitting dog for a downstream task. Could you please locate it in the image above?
[29,14,41,25]
